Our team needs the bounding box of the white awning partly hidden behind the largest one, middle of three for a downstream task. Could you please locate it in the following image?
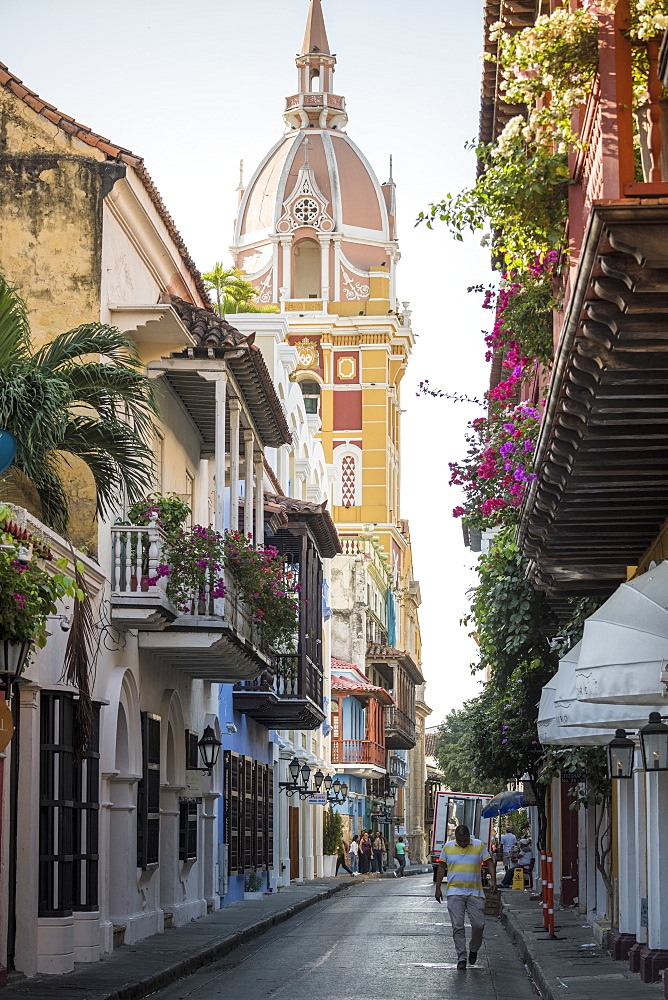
[554,642,654,743]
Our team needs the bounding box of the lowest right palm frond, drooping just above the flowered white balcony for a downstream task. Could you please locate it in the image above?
[60,416,155,517]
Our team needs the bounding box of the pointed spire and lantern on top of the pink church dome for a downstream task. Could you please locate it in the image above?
[283,0,348,131]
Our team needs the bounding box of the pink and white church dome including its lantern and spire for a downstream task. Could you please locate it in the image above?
[231,0,399,315]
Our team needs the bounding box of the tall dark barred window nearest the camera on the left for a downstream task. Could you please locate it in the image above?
[38,691,100,917]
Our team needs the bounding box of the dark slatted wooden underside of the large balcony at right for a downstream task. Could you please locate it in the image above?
[520,199,668,598]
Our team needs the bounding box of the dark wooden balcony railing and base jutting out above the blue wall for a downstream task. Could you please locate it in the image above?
[233,654,325,729]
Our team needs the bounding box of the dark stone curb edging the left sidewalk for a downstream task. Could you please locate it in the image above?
[113,882,355,1000]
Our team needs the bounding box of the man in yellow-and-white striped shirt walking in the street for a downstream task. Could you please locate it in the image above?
[434,826,497,969]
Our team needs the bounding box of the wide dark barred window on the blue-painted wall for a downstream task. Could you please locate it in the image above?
[225,750,274,875]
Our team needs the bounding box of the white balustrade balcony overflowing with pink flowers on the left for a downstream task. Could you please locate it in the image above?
[111,495,299,683]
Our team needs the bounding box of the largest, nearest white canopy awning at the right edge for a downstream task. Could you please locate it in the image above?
[575,560,668,704]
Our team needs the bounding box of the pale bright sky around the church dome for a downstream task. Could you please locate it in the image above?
[0,0,491,725]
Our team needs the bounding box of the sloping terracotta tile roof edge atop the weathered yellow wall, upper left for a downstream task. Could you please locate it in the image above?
[0,62,210,305]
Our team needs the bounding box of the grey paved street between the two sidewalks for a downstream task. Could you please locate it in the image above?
[150,875,537,1000]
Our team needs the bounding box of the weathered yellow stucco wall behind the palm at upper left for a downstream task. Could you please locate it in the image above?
[0,87,124,553]
